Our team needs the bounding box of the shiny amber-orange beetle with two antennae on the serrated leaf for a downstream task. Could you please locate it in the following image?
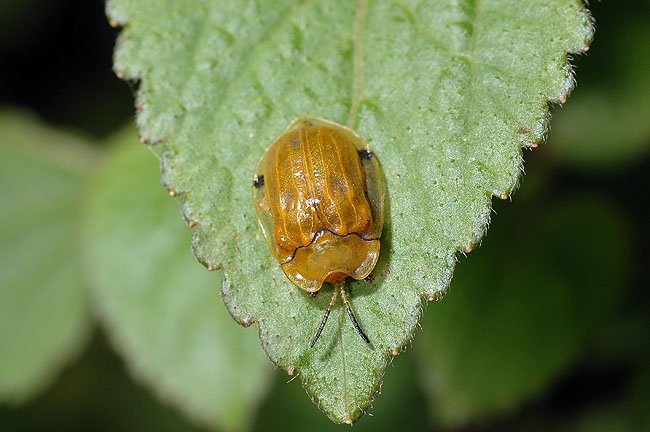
[253,116,384,348]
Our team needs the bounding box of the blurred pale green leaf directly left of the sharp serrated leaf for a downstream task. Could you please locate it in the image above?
[85,131,270,431]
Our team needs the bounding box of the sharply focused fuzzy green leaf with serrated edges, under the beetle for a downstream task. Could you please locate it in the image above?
[108,0,592,423]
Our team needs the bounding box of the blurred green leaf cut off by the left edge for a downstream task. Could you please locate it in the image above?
[0,112,94,403]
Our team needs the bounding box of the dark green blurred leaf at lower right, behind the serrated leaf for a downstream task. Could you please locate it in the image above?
[418,197,629,424]
